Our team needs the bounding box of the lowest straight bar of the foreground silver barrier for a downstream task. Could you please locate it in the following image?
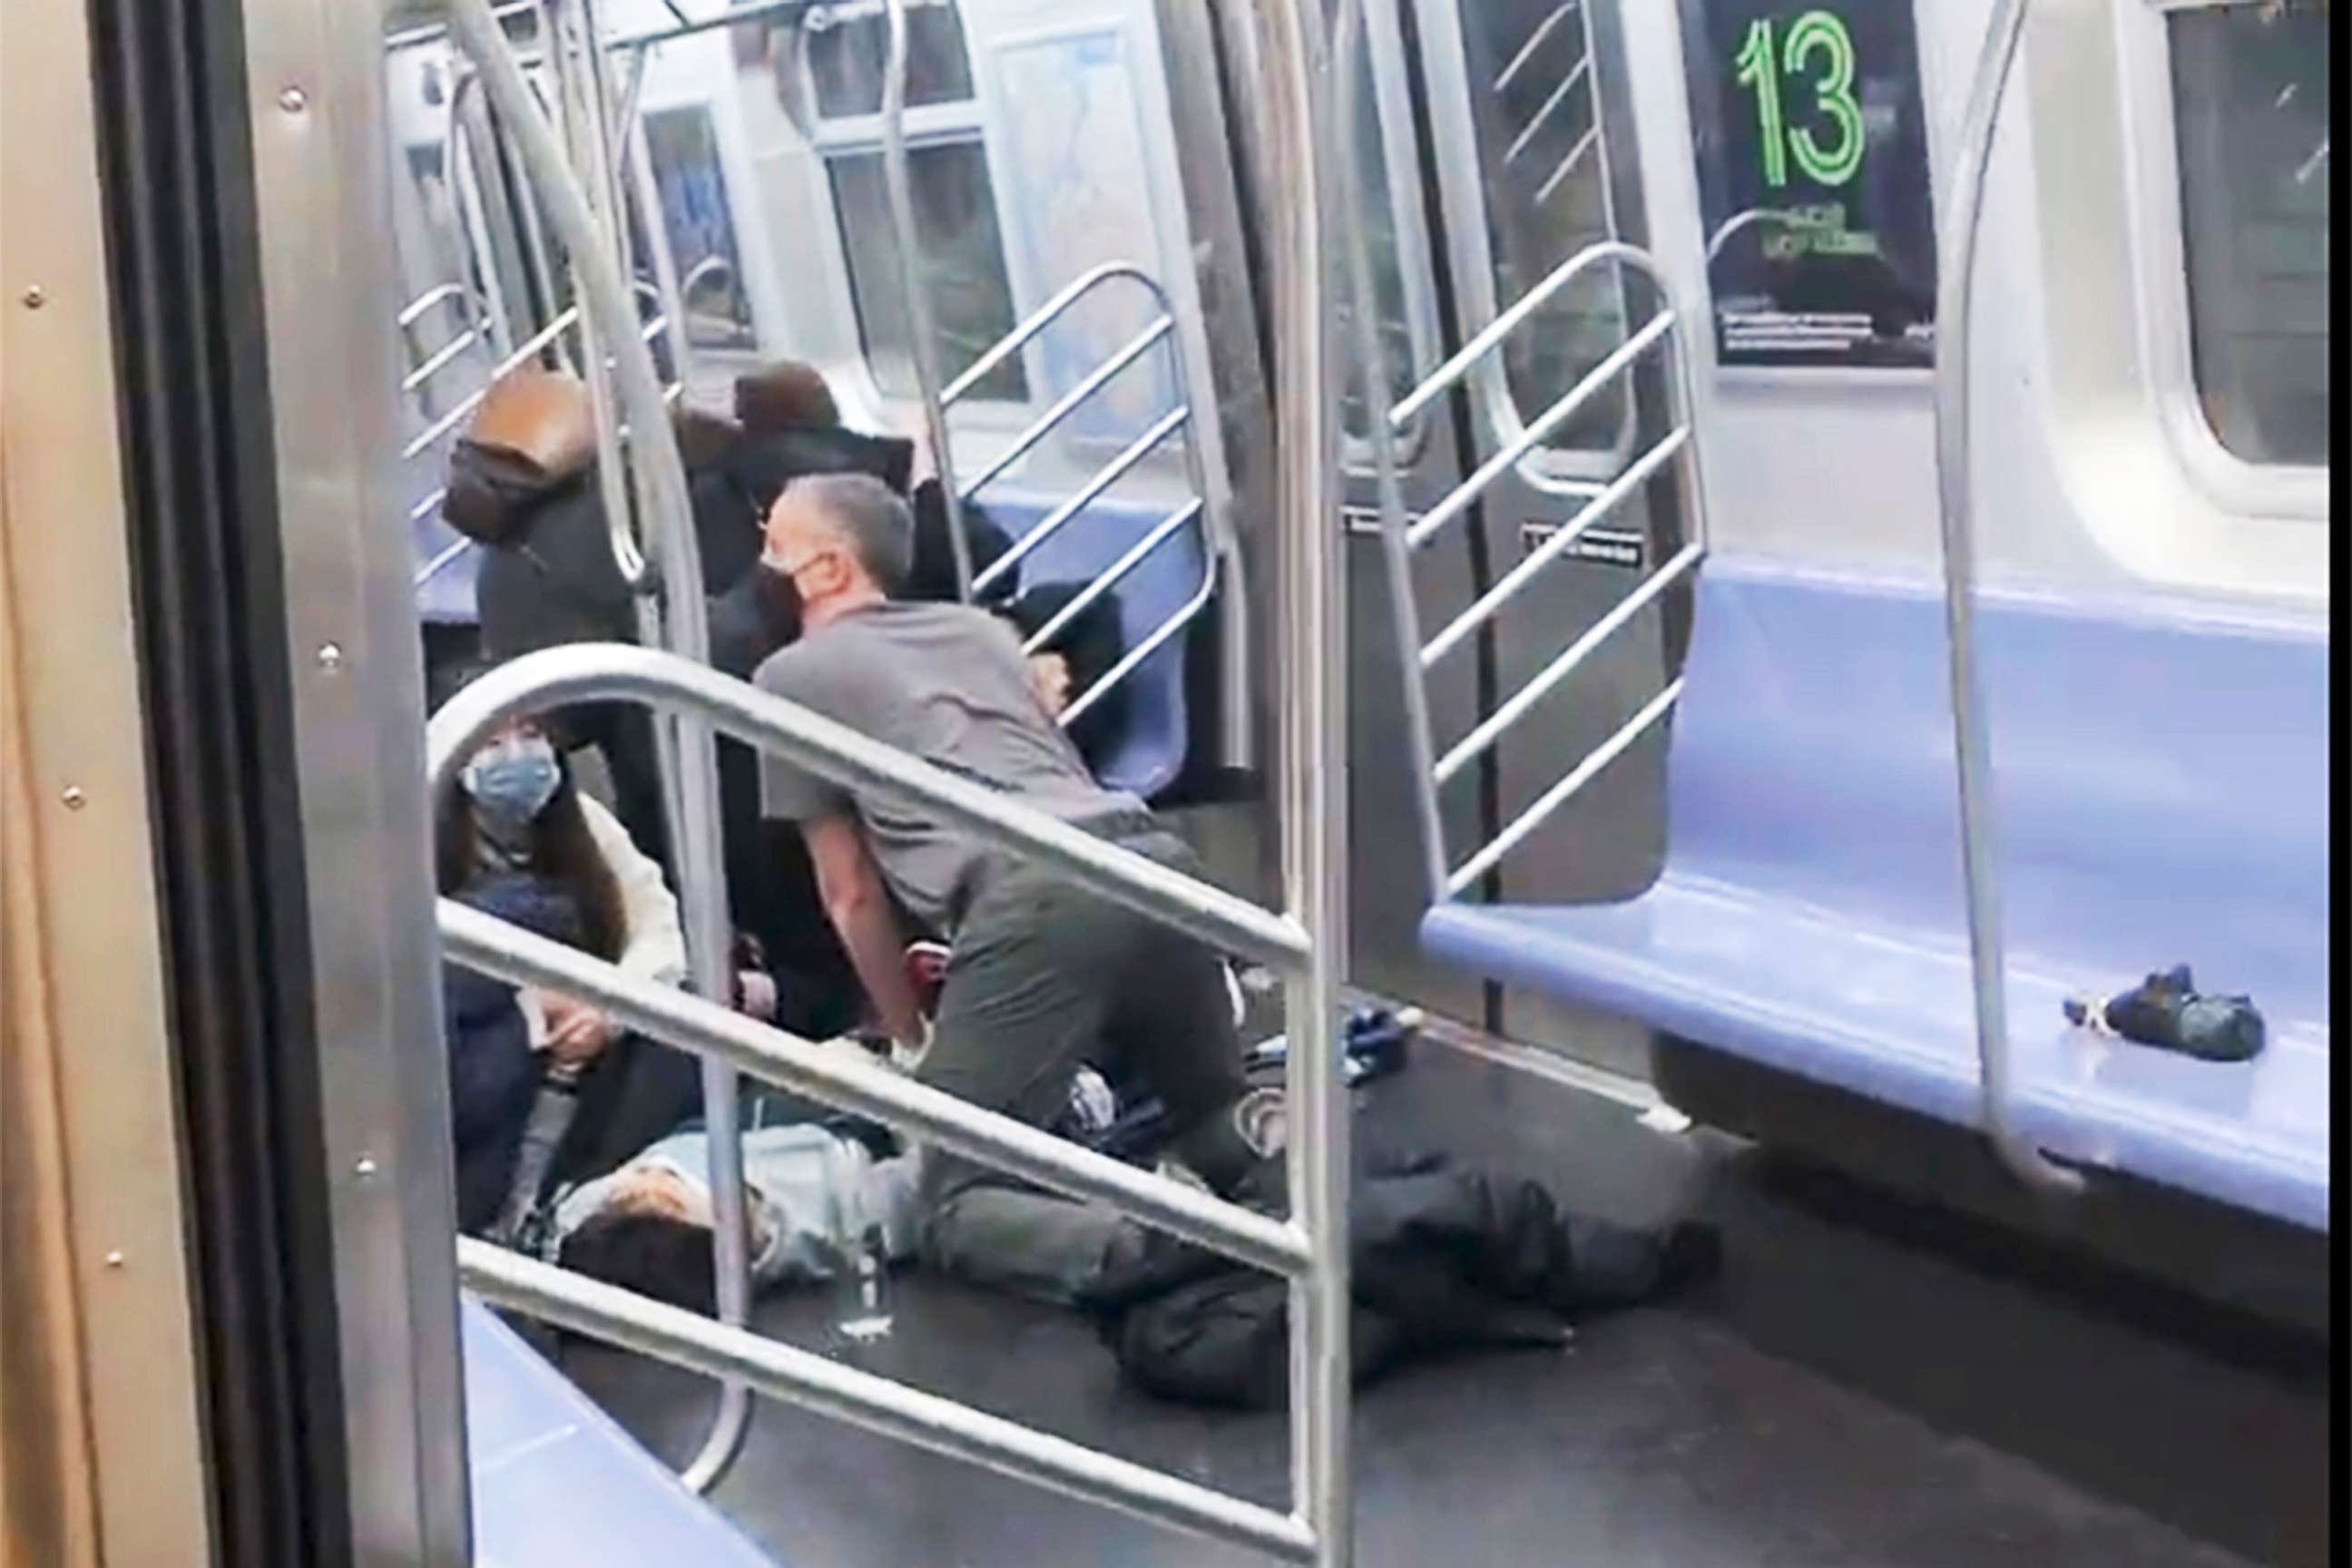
[456,1239,1315,1563]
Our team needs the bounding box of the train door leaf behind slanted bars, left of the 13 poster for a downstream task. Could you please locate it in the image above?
[1414,0,1680,1074]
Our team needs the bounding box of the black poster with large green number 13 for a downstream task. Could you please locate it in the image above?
[1680,0,1936,369]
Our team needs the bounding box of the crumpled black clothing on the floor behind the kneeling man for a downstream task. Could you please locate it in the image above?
[1082,1157,1715,1408]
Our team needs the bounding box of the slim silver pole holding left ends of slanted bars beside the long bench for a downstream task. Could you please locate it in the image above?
[1318,0,1446,907]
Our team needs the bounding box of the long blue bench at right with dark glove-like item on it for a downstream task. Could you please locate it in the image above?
[1423,557,2331,1230]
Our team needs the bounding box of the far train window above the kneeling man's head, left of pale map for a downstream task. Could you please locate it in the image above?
[802,5,1028,402]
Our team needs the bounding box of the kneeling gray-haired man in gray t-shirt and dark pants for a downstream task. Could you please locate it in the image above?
[752,475,1272,1293]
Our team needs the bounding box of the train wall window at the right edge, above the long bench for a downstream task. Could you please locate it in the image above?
[2169,0,2331,466]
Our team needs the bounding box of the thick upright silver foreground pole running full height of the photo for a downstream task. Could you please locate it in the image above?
[1259,0,1355,1568]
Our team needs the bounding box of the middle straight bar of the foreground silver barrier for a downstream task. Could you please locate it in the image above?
[440,902,1308,1277]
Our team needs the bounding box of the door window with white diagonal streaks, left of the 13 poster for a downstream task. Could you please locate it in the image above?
[1461,0,1646,449]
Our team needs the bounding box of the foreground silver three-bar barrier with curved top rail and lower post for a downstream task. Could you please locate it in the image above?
[426,644,1348,1568]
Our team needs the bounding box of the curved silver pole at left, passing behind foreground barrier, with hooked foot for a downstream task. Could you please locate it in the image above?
[449,0,750,1491]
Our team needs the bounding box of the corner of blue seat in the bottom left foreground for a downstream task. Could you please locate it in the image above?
[458,1298,774,1568]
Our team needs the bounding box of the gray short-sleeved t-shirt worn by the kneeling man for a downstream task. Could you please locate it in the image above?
[752,602,1143,936]
